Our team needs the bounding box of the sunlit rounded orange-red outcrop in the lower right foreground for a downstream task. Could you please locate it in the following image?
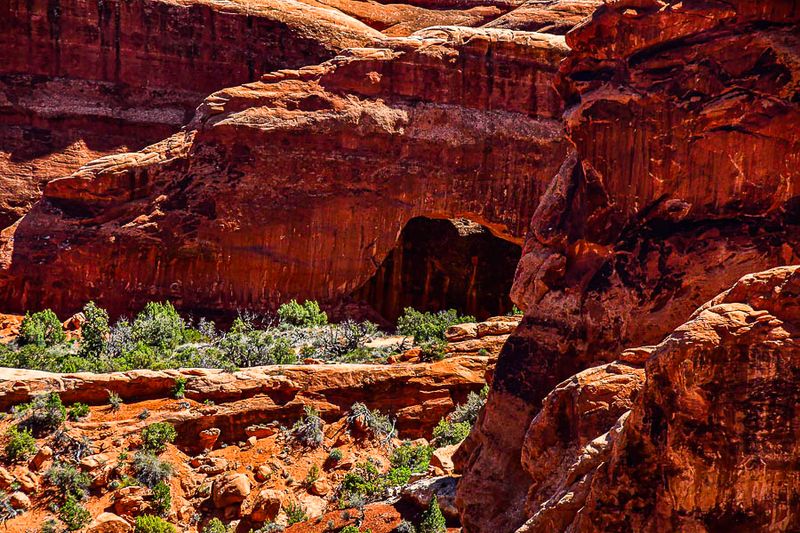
[510,267,800,533]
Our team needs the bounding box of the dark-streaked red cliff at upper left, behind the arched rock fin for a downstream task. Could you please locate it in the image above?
[0,0,380,227]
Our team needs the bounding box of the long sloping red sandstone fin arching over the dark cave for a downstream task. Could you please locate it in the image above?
[0,28,566,314]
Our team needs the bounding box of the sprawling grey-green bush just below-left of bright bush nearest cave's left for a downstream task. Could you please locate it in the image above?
[218,318,297,368]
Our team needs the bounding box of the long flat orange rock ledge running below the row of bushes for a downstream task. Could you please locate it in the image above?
[0,355,490,440]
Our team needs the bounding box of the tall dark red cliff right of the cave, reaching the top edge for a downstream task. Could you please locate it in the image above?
[459,0,800,531]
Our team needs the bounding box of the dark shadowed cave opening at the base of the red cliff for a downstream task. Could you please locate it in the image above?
[352,217,522,323]
